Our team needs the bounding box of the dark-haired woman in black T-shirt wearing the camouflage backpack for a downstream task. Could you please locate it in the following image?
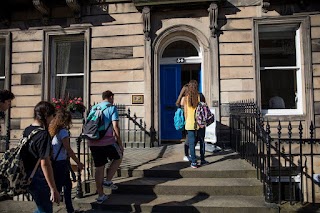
[22,101,60,213]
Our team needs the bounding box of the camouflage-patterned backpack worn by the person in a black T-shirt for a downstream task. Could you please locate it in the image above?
[0,128,44,197]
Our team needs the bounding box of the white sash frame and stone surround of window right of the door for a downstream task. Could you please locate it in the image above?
[254,17,313,116]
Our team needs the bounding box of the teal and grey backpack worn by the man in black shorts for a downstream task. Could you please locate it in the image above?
[81,105,112,140]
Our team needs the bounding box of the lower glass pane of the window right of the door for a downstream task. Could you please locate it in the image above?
[260,70,297,109]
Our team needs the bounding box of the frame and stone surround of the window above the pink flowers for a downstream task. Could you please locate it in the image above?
[42,27,90,108]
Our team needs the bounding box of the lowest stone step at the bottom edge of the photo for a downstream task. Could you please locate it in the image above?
[74,193,278,213]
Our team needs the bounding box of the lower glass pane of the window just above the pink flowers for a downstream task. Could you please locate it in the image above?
[55,76,83,98]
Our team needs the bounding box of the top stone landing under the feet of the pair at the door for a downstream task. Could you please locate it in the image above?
[118,150,257,178]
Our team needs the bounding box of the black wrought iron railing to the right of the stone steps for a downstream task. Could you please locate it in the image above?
[230,101,320,204]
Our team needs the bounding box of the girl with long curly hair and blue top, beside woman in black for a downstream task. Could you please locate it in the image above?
[49,108,84,213]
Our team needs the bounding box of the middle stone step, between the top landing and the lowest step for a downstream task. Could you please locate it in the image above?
[98,177,263,196]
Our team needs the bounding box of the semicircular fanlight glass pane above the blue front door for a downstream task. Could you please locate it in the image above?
[162,41,199,58]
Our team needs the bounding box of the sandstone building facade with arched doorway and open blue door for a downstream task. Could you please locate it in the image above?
[0,0,320,145]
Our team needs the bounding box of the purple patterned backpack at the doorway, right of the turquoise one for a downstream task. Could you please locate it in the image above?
[194,101,214,128]
